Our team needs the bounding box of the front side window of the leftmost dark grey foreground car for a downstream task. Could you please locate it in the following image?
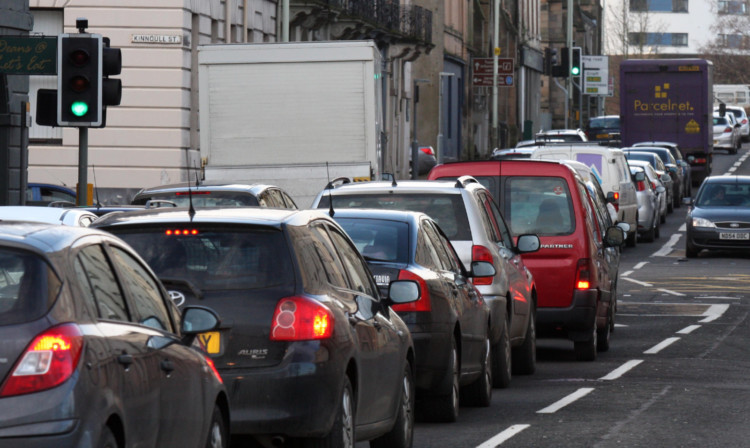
[110,246,174,332]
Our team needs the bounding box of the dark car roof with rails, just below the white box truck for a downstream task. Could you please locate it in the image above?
[131,182,298,209]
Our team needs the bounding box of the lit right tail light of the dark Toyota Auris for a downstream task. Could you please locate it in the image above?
[270,296,334,341]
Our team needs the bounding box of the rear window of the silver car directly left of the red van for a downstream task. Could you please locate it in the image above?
[318,192,471,241]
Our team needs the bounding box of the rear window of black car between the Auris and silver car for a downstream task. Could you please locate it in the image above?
[334,218,409,264]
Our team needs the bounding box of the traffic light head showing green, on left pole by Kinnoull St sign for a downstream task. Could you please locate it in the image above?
[57,33,102,127]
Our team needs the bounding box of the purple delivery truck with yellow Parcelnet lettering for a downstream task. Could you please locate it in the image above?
[620,59,714,183]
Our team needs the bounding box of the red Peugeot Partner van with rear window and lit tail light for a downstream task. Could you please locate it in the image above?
[428,159,624,361]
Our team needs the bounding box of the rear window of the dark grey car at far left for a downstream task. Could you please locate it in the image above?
[0,247,62,325]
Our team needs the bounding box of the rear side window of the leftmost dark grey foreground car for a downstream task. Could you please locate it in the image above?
[75,244,130,322]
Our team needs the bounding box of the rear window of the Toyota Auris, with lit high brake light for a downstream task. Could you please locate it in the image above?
[110,228,294,290]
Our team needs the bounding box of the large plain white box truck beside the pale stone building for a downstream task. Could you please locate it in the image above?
[198,41,383,207]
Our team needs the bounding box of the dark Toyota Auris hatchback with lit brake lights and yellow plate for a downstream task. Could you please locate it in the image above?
[95,207,418,448]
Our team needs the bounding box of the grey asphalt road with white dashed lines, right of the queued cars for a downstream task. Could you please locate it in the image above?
[406,144,750,448]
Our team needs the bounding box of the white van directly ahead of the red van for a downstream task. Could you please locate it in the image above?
[531,144,638,247]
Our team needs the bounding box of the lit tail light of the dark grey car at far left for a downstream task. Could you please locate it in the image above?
[0,324,83,397]
